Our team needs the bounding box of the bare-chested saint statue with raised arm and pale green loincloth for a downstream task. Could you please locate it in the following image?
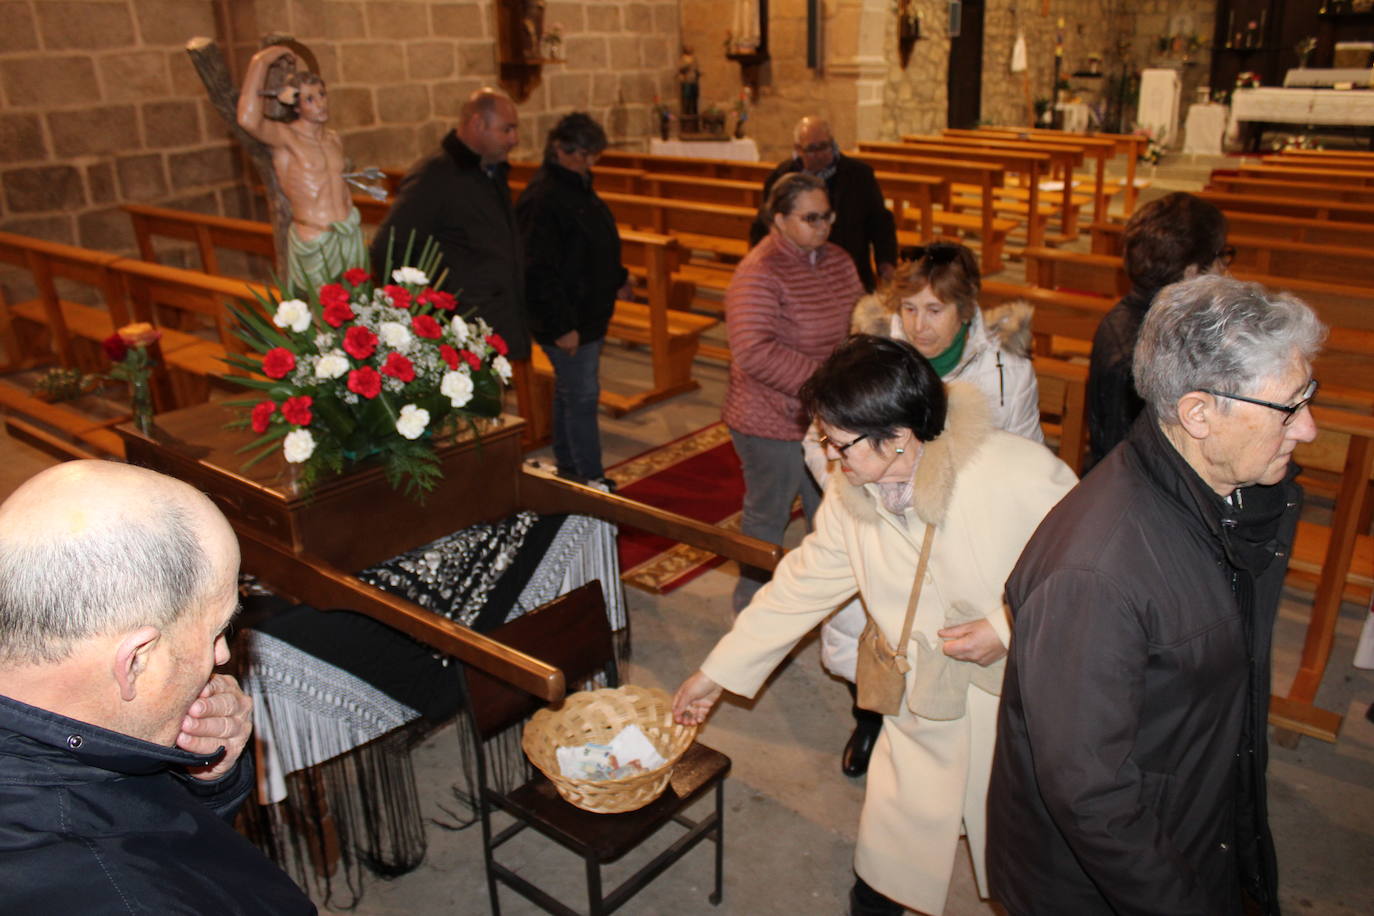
[238,44,368,293]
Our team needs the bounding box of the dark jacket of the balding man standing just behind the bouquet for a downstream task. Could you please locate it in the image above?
[372,130,529,360]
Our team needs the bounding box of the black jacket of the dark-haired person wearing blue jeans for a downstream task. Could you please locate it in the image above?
[515,162,628,345]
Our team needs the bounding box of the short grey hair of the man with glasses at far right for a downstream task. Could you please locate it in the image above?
[1134,275,1326,423]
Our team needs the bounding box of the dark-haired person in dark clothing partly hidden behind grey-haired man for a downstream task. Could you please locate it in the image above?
[1087,191,1235,467]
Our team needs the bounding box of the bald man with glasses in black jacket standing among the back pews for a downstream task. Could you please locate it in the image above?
[749,117,897,293]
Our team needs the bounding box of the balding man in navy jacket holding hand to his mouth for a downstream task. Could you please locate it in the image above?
[0,461,316,915]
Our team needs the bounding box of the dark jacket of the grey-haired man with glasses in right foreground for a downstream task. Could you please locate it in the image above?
[988,409,1301,916]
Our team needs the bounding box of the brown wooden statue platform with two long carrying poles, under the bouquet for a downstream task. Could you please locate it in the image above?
[117,404,782,702]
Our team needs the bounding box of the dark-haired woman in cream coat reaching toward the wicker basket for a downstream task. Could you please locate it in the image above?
[673,335,1074,915]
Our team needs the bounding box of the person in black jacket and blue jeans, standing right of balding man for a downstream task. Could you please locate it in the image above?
[515,111,632,489]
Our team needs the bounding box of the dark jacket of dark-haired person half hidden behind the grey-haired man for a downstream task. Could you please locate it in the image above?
[1087,288,1157,468]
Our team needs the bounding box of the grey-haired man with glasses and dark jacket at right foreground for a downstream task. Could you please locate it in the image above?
[988,276,1325,916]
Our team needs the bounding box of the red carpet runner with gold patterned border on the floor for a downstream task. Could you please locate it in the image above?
[606,423,745,595]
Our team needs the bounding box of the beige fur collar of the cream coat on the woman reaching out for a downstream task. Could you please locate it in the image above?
[831,382,992,526]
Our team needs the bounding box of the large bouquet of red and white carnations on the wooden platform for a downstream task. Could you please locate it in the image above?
[224,242,511,500]
